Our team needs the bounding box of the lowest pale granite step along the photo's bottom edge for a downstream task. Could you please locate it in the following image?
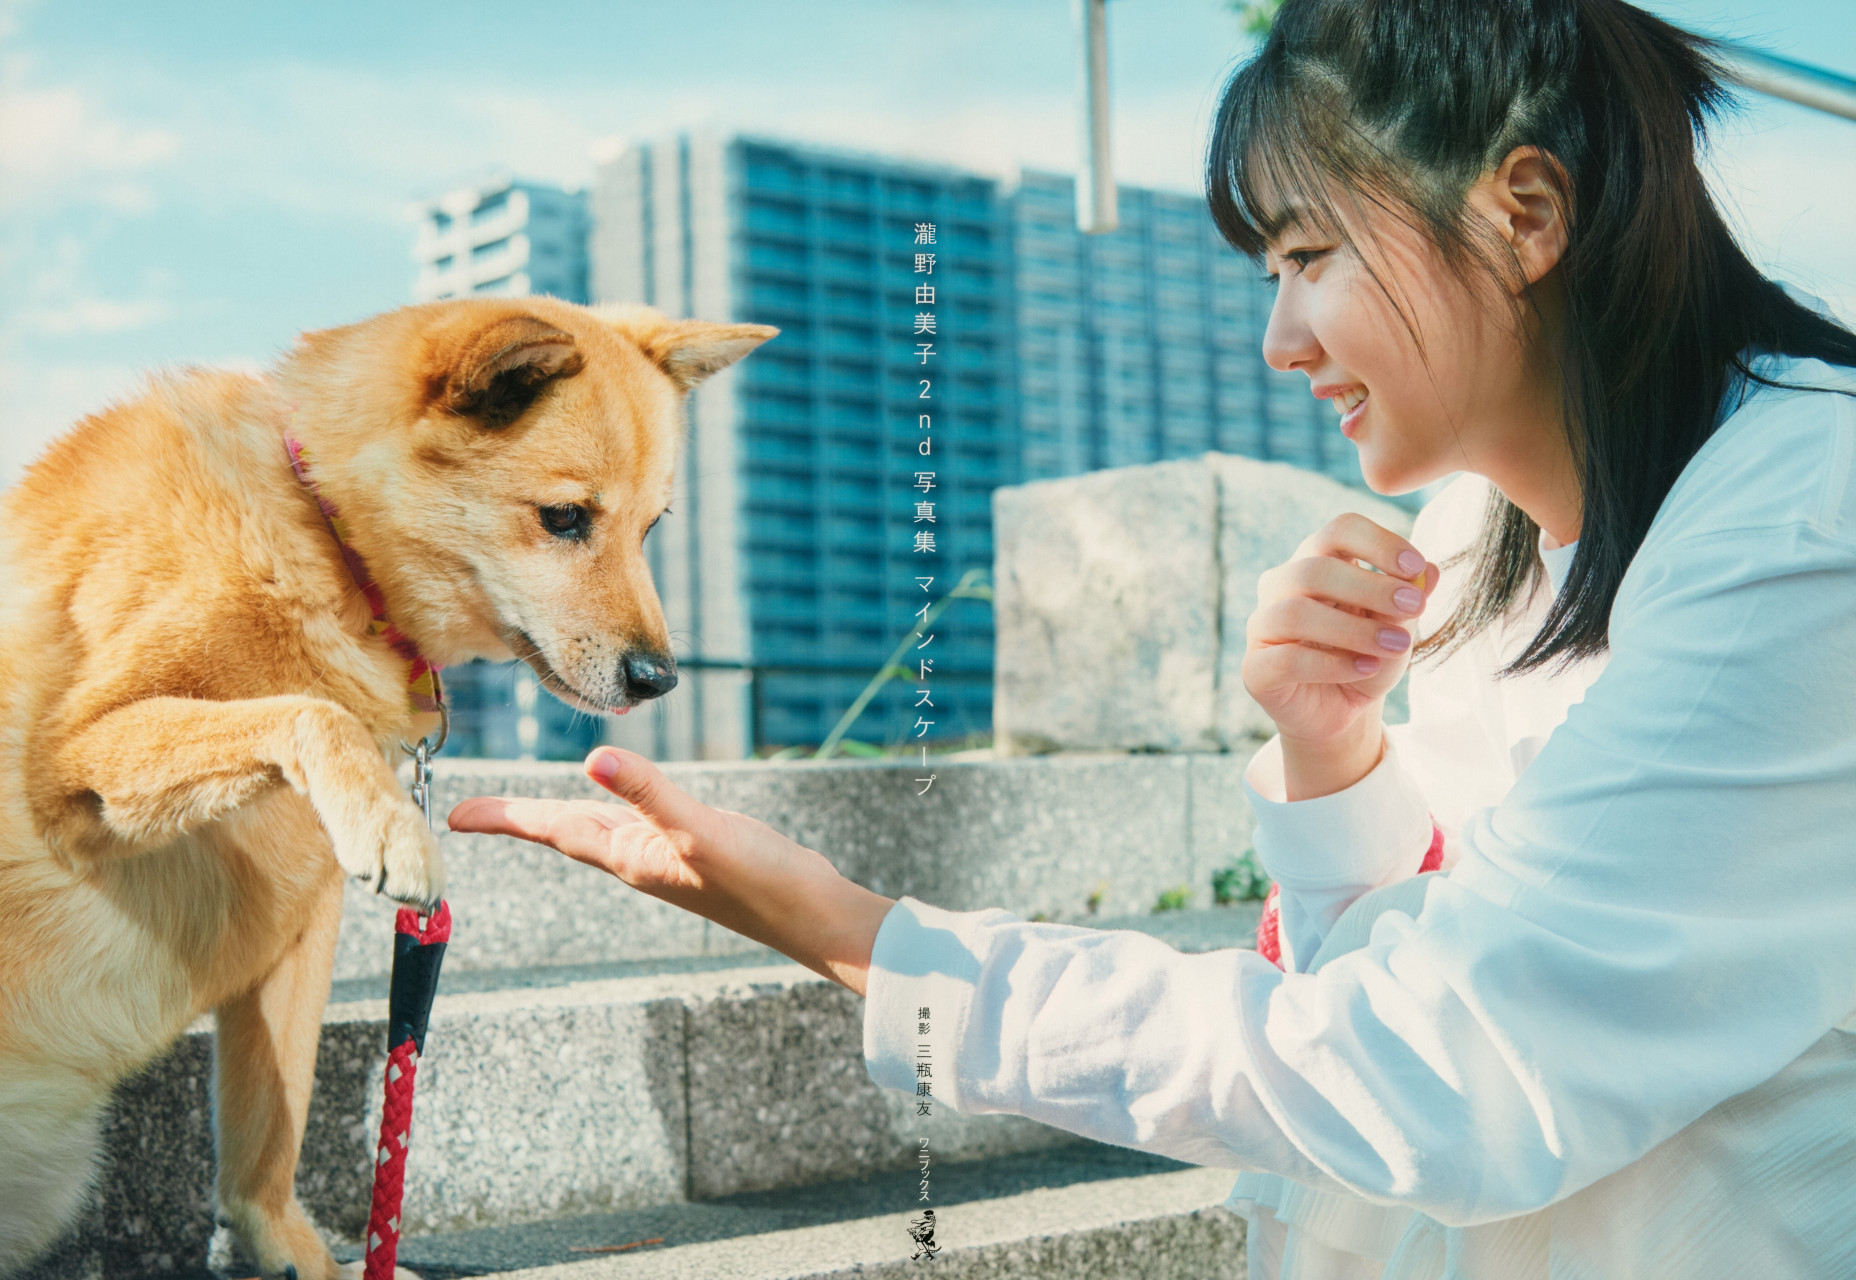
[270,1142,1245,1280]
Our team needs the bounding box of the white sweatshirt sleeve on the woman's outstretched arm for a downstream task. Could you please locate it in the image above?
[865,523,1856,1224]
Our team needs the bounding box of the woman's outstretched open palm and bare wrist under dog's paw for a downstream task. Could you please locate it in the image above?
[449,748,895,996]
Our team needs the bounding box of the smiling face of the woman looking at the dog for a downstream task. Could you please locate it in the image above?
[1264,153,1565,534]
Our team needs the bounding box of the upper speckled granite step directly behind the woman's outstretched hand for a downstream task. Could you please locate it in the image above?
[336,748,1255,979]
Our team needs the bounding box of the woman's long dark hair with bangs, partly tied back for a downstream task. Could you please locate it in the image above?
[1206,0,1856,675]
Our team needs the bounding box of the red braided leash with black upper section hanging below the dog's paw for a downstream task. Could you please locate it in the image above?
[364,902,451,1280]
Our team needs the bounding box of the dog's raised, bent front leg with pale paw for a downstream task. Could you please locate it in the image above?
[32,696,444,907]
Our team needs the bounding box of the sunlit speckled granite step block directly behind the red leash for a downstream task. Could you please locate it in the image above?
[319,979,687,1239]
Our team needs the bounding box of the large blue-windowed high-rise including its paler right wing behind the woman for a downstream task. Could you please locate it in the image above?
[590,135,1395,759]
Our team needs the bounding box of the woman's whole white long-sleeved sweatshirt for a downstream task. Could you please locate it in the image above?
[865,348,1856,1280]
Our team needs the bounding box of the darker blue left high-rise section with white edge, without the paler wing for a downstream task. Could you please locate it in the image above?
[592,135,1021,759]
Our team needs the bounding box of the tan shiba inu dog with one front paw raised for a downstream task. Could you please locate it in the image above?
[0,297,778,1280]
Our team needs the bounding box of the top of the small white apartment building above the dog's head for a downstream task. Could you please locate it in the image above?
[412,178,586,302]
